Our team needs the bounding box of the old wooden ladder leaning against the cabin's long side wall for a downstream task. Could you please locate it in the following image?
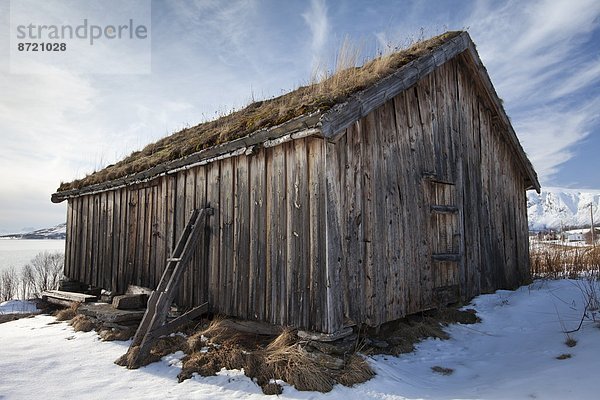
[115,208,213,369]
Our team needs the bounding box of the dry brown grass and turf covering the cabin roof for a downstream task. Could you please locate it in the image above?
[58,31,461,192]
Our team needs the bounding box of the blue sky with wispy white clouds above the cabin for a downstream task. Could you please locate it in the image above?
[0,0,600,232]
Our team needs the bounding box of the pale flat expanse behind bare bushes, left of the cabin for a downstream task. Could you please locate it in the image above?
[0,239,65,272]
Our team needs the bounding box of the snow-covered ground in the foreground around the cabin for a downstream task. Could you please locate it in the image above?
[0,280,600,400]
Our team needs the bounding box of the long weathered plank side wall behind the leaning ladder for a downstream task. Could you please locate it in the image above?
[65,138,335,331]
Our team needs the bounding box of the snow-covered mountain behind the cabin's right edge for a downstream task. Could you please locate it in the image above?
[527,187,600,230]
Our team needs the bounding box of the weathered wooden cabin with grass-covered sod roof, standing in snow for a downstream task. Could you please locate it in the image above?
[52,32,540,333]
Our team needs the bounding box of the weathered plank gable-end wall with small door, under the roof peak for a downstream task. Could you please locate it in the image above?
[327,54,528,325]
